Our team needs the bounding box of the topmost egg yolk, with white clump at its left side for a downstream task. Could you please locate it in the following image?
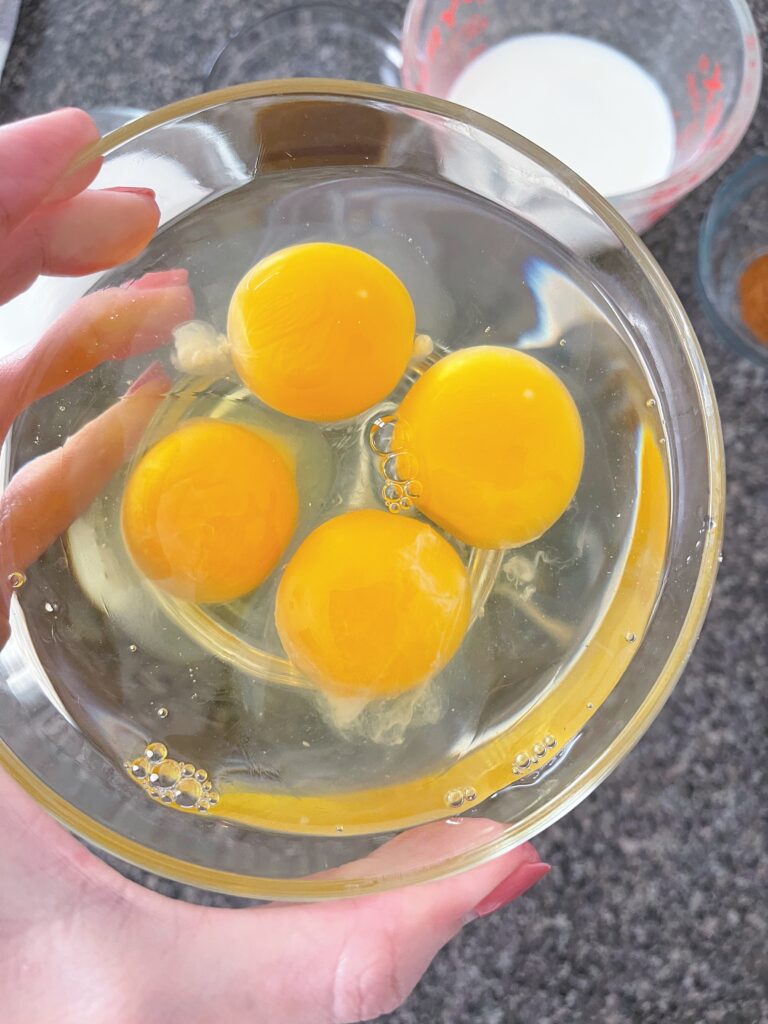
[227,242,416,422]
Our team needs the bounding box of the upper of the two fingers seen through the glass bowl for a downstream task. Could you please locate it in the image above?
[0,269,195,441]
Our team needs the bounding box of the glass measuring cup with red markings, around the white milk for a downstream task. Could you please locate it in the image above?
[402,0,762,231]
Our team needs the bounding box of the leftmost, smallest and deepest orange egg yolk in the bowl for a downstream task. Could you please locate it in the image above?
[122,420,298,603]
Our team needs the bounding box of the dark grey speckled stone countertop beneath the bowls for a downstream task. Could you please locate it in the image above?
[0,0,768,1024]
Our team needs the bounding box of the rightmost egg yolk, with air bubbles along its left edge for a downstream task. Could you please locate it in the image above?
[393,345,584,548]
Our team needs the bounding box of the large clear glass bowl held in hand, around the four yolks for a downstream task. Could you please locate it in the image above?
[0,80,724,899]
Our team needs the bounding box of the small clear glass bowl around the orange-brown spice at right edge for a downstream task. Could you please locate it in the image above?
[698,154,768,367]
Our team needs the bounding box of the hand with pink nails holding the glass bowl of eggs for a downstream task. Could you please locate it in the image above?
[0,111,548,1024]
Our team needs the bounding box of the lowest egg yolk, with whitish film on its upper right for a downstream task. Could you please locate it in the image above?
[275,509,470,697]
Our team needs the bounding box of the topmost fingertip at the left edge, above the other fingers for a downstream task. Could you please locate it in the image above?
[0,108,100,239]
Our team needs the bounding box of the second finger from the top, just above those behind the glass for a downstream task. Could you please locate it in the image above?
[0,188,160,303]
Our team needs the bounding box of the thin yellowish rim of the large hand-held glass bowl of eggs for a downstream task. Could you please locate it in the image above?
[0,79,725,901]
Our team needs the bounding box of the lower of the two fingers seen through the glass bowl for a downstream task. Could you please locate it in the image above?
[0,364,170,638]
